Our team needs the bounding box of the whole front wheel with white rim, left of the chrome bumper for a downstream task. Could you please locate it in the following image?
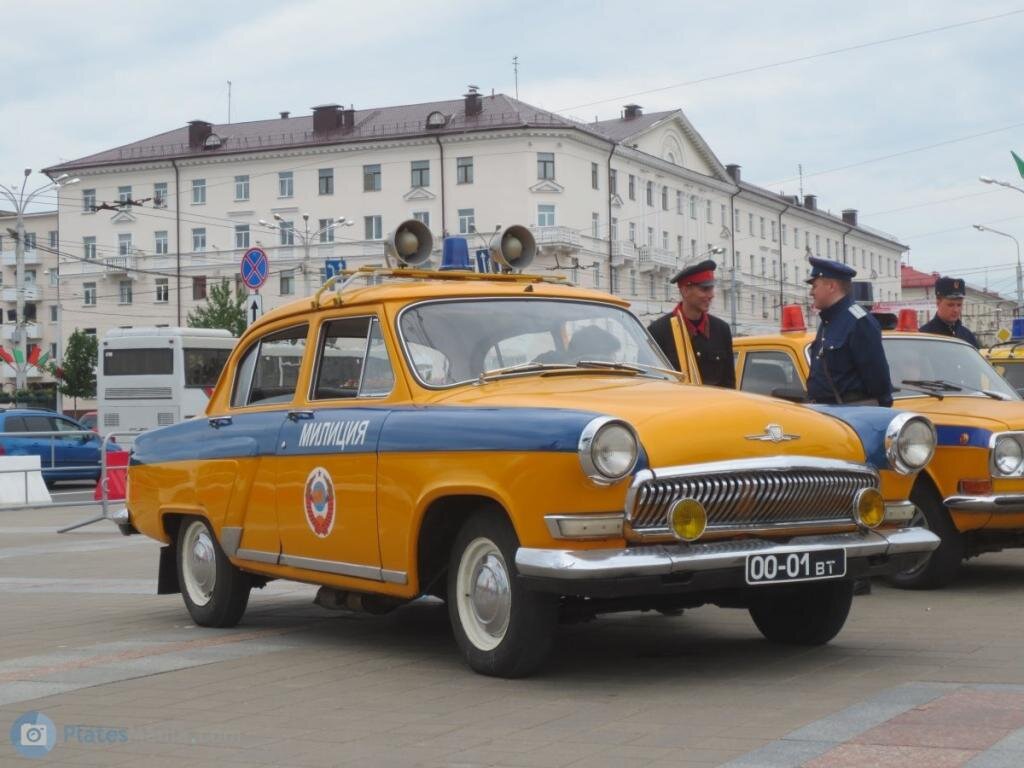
[447,511,558,678]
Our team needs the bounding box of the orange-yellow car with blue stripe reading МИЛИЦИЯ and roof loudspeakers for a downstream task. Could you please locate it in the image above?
[123,222,938,676]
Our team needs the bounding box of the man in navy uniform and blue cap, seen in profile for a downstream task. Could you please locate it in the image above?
[807,257,893,406]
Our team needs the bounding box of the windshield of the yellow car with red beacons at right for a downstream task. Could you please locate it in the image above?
[882,337,1020,400]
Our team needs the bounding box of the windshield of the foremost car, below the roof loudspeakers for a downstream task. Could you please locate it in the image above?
[398,298,674,387]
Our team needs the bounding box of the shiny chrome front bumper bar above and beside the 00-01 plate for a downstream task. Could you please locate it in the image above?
[515,527,939,581]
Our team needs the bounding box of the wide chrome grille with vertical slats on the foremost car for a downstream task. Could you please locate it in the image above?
[626,460,879,538]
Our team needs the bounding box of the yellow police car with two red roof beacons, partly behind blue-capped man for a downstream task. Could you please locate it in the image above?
[734,305,1024,589]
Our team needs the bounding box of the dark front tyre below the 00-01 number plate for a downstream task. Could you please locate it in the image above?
[750,579,853,645]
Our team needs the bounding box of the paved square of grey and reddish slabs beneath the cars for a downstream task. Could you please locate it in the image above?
[0,509,1024,768]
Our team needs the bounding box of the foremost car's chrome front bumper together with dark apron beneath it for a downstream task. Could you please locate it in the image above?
[516,527,939,595]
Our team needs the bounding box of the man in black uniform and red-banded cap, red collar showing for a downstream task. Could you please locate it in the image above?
[647,259,736,389]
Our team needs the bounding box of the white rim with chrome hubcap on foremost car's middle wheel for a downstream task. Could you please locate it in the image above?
[458,538,512,650]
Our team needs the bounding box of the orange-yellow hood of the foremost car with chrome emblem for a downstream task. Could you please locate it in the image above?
[432,373,864,467]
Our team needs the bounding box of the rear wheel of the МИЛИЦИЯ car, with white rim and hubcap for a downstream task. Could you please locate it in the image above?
[177,517,252,627]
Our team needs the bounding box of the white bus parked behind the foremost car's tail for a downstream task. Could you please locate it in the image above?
[96,328,238,434]
